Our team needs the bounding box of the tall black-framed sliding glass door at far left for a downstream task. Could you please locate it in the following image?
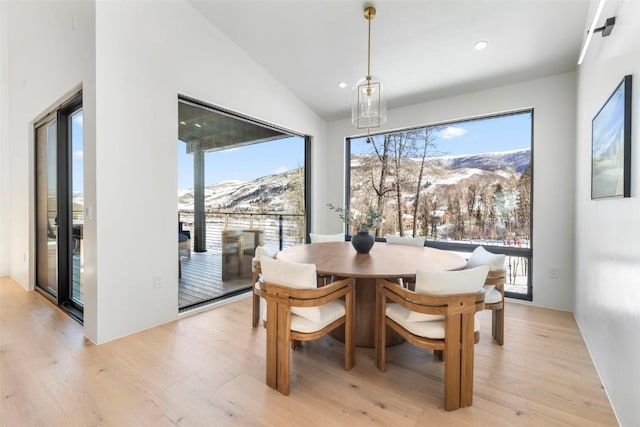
[34,94,84,321]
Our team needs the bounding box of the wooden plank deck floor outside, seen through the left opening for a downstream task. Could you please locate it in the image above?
[178,252,251,310]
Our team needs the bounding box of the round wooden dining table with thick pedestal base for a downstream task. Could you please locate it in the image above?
[276,242,466,347]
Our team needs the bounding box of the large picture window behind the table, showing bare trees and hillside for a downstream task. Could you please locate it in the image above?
[347,110,533,299]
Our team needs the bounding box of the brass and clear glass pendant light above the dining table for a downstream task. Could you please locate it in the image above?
[351,6,387,129]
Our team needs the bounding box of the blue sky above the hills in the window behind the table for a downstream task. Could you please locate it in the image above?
[351,112,531,155]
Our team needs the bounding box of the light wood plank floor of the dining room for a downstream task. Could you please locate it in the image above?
[0,278,617,426]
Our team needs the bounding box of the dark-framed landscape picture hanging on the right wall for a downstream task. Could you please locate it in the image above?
[591,75,631,199]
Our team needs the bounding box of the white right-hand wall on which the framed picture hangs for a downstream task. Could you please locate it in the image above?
[575,1,640,426]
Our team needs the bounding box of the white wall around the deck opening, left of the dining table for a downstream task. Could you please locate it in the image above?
[92,1,326,342]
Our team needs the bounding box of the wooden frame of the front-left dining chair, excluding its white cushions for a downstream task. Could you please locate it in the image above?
[260,278,356,395]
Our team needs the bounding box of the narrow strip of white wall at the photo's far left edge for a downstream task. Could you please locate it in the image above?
[0,1,11,277]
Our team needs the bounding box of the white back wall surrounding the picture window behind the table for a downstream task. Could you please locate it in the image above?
[322,73,576,311]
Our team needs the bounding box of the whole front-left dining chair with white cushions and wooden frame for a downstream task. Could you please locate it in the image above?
[259,256,355,395]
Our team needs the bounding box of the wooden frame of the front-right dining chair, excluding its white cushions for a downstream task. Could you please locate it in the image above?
[376,279,484,411]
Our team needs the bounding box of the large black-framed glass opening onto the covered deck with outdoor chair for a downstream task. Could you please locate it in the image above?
[176,96,311,311]
